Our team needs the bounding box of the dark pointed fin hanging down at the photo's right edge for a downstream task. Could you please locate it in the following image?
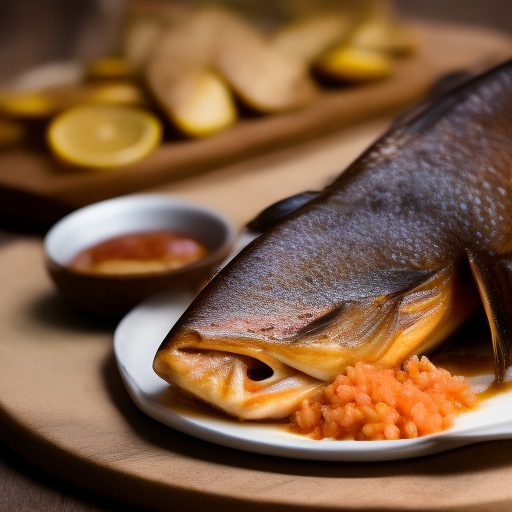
[468,253,512,383]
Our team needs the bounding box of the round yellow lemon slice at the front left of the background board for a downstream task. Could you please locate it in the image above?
[47,105,162,169]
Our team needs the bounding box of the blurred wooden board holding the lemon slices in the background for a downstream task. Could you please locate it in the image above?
[0,23,512,226]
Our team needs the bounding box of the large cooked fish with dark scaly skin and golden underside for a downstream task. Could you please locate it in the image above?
[154,63,512,419]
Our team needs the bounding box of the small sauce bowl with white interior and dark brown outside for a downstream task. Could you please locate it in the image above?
[44,194,236,318]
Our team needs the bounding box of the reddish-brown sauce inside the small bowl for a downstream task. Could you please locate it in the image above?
[68,231,208,275]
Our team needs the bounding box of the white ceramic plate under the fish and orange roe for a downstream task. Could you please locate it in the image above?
[114,293,512,461]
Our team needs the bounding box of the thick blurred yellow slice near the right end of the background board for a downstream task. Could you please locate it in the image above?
[316,46,393,83]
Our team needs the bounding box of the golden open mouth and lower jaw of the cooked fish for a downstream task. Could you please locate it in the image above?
[153,332,326,420]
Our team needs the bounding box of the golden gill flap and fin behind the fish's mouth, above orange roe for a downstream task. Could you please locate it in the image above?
[295,263,478,374]
